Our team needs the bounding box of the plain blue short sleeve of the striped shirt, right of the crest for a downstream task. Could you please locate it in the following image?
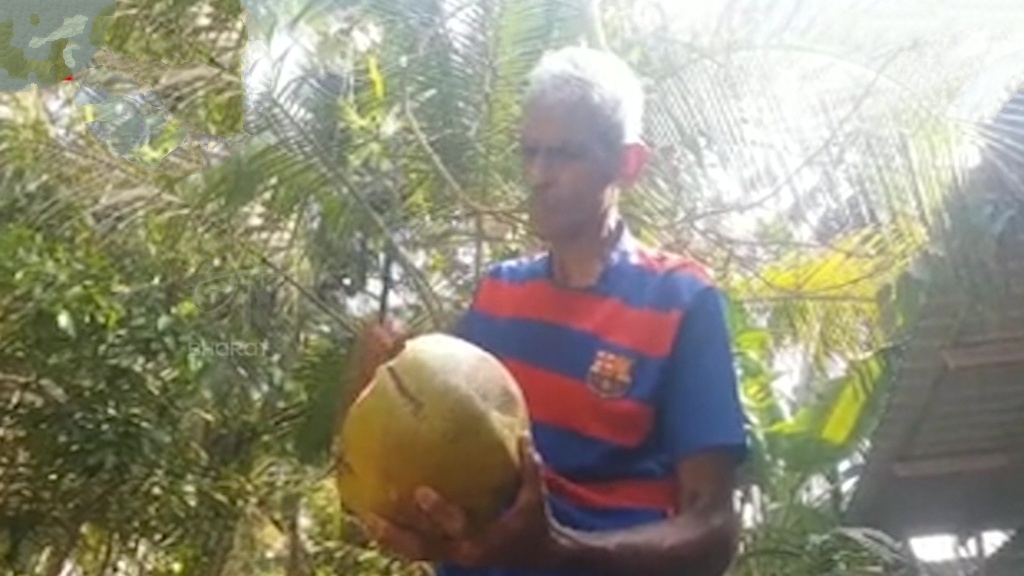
[659,286,748,462]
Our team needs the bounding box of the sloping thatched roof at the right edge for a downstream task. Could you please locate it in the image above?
[849,88,1024,532]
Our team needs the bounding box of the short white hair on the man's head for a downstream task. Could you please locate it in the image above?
[525,46,644,147]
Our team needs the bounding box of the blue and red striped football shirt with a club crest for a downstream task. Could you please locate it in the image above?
[438,224,746,576]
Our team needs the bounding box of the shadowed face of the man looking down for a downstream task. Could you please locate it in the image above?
[520,104,620,242]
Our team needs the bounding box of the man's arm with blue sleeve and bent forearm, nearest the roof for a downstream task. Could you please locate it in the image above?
[551,288,745,576]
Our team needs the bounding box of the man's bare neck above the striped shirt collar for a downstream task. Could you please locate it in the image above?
[551,215,622,288]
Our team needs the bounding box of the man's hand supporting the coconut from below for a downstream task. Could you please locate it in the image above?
[367,439,558,569]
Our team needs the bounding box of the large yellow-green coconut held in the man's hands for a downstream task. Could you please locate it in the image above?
[336,333,529,529]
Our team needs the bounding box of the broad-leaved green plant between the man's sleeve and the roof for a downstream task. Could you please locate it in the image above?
[730,291,921,576]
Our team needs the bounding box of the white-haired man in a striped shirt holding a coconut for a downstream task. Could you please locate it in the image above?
[356,48,745,576]
